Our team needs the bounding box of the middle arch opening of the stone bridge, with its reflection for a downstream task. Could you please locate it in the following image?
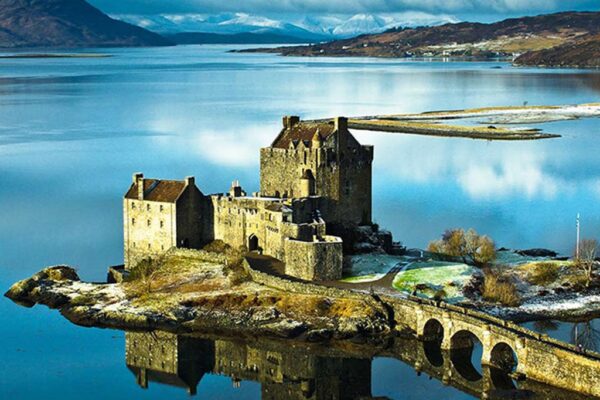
[450,330,483,382]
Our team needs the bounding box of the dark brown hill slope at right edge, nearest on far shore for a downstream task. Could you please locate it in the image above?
[515,35,600,68]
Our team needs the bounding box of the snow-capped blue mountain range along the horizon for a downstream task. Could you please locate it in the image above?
[114,12,458,40]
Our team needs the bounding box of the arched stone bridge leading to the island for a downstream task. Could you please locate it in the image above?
[381,296,600,397]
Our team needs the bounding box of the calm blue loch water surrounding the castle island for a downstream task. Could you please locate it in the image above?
[0,46,600,399]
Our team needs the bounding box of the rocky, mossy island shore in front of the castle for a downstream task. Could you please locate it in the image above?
[5,255,392,341]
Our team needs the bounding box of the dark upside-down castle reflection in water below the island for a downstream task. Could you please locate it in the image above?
[125,332,371,399]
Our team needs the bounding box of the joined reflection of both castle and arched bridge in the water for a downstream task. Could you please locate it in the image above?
[125,327,590,400]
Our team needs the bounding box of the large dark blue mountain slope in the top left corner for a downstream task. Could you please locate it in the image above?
[0,0,172,48]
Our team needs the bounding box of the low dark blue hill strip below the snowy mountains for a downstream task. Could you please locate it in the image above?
[165,32,307,44]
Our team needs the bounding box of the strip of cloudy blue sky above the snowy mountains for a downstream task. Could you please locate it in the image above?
[88,0,600,22]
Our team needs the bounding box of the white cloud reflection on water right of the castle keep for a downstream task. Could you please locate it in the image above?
[368,133,568,200]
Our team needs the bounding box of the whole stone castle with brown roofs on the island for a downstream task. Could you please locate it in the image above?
[123,116,373,281]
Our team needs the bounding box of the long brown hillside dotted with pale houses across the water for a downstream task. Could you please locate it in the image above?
[243,12,600,57]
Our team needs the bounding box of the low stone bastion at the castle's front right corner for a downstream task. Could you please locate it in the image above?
[284,236,343,281]
